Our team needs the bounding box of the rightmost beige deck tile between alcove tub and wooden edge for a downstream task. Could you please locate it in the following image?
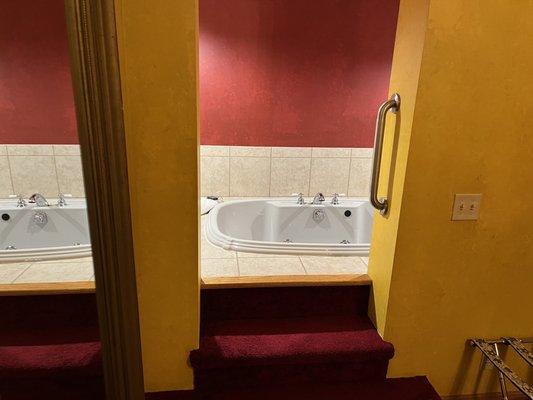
[300,256,367,275]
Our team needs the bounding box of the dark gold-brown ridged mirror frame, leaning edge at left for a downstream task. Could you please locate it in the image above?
[66,0,144,400]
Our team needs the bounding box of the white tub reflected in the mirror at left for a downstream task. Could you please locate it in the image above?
[0,199,91,263]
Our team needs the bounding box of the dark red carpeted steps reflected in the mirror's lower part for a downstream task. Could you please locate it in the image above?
[0,294,103,400]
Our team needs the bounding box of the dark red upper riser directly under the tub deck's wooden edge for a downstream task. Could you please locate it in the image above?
[201,286,370,322]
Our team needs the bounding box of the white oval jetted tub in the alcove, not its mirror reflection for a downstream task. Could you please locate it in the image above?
[206,198,373,257]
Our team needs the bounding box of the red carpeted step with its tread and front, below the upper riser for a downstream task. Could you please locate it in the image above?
[190,315,394,389]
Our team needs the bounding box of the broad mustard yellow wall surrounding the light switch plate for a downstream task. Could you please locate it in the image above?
[369,0,533,395]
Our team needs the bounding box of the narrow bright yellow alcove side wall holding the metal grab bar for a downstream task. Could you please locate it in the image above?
[368,0,430,335]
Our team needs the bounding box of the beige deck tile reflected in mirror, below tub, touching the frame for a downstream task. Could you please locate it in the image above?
[14,262,94,283]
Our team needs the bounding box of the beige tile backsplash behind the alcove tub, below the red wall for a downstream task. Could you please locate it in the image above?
[200,146,372,197]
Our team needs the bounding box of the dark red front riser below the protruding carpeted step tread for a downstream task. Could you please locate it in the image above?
[194,361,388,392]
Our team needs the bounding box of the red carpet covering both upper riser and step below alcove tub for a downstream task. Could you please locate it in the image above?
[190,286,394,392]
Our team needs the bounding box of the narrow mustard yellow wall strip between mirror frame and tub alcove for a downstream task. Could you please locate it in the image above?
[115,0,199,391]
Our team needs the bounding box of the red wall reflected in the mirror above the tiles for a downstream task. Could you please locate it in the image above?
[0,0,78,144]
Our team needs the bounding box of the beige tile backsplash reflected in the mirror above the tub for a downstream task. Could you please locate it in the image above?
[0,145,85,198]
